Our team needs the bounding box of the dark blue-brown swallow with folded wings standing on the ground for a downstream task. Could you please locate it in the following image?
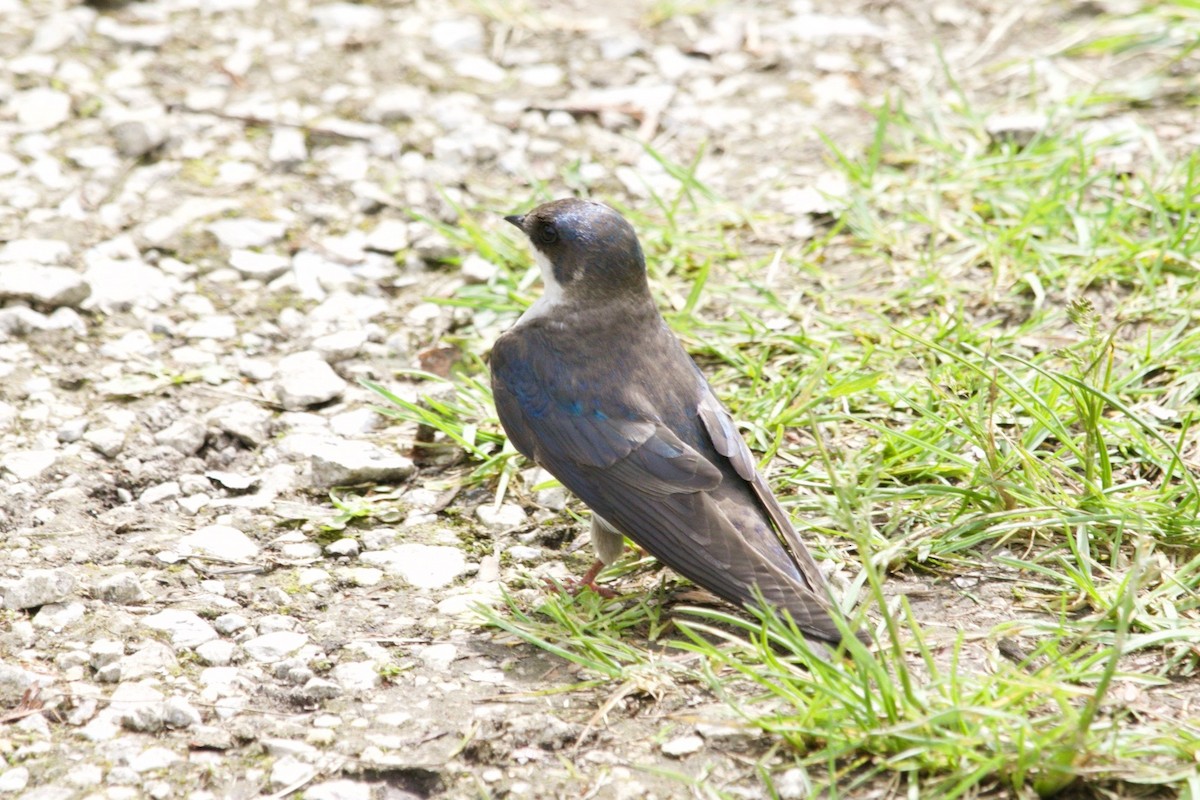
[490,198,868,645]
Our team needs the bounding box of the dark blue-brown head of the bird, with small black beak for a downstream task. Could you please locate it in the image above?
[505,198,649,301]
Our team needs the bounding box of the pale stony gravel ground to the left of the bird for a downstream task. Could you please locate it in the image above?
[0,0,1185,800]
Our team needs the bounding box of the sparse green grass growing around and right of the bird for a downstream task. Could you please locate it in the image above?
[367,2,1200,798]
